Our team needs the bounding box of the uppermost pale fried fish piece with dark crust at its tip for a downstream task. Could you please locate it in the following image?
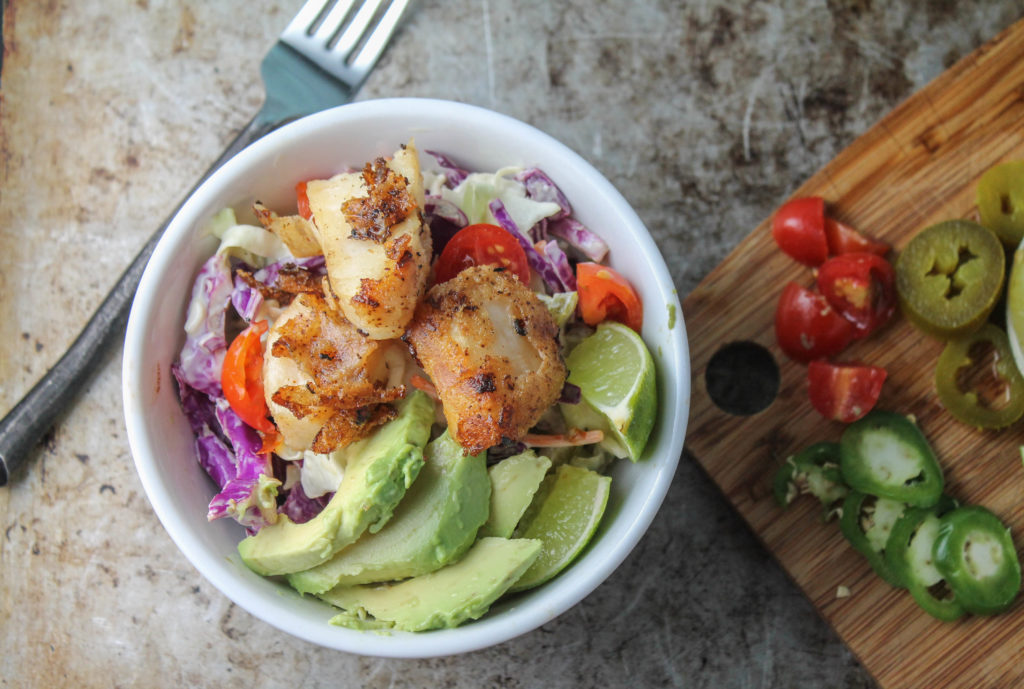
[306,142,431,340]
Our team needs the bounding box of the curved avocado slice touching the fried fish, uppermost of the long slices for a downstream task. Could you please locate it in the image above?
[239,390,434,575]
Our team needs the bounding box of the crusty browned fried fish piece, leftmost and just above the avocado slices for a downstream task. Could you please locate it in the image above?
[263,293,409,454]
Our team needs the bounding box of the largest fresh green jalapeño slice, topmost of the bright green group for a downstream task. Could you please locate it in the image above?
[840,410,943,507]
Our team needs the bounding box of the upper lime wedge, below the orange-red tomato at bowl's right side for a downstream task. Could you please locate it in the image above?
[562,321,657,462]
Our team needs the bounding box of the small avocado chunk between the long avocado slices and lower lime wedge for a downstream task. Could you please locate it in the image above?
[480,449,551,539]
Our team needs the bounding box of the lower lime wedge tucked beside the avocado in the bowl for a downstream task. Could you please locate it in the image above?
[511,464,611,591]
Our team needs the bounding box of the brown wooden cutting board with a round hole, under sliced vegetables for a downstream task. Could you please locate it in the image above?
[683,16,1024,689]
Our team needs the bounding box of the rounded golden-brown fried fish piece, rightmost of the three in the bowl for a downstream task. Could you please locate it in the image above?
[406,265,566,453]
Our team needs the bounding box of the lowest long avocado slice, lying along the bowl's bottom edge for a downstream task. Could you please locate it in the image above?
[319,537,541,632]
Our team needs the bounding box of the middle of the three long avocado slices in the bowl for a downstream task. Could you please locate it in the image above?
[288,431,490,594]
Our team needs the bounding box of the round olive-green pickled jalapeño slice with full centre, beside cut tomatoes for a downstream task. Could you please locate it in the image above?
[896,220,1006,338]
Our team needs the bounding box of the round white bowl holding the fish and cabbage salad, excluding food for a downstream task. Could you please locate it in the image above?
[123,98,690,657]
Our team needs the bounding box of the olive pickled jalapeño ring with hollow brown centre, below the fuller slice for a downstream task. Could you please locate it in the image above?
[935,324,1024,428]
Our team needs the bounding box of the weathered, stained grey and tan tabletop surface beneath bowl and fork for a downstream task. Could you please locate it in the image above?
[0,0,1024,689]
